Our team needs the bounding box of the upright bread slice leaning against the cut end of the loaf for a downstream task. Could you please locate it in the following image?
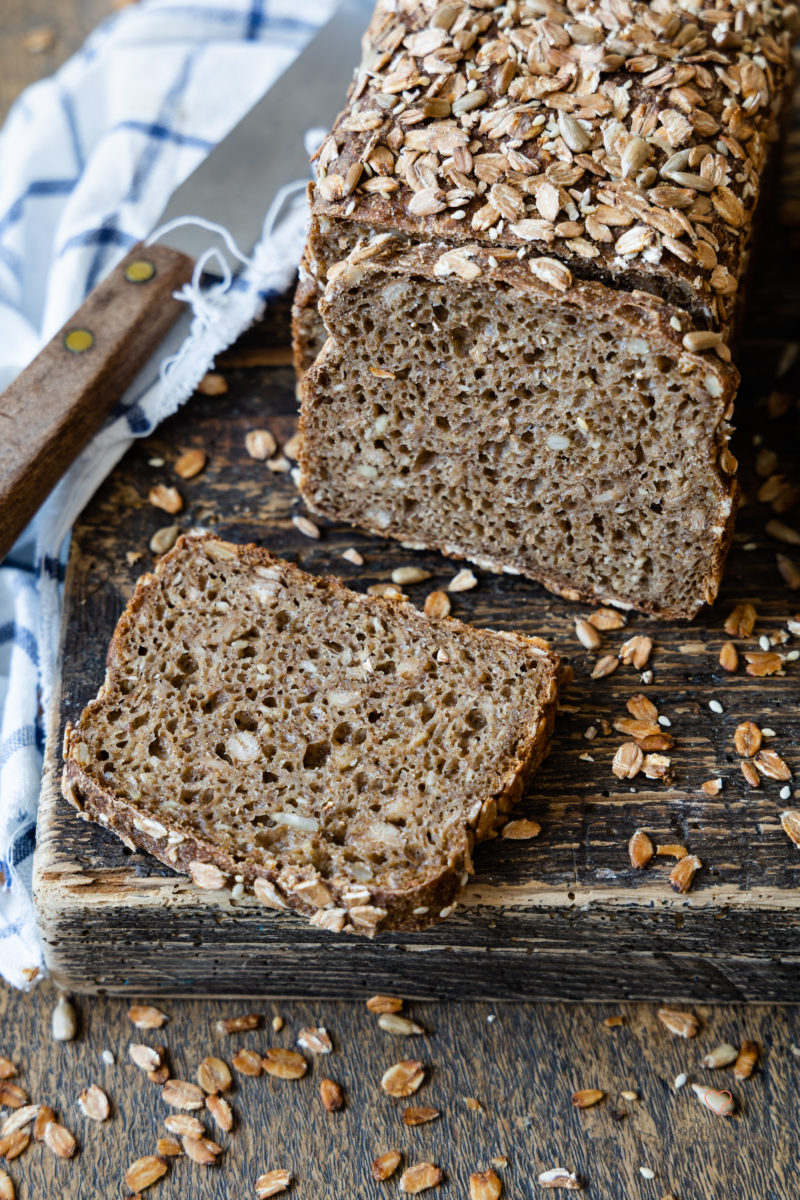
[300,239,736,617]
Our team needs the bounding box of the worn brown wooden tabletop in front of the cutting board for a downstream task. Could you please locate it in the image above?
[0,978,800,1200]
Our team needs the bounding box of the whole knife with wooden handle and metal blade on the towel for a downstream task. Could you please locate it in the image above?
[0,0,373,562]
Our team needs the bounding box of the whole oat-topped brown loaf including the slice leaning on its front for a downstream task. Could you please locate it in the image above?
[295,0,796,618]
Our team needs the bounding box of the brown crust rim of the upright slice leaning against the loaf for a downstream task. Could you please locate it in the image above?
[299,242,740,620]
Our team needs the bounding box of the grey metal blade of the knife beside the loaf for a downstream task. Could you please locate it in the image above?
[155,0,373,258]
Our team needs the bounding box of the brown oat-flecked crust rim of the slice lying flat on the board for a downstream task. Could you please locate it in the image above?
[61,534,559,936]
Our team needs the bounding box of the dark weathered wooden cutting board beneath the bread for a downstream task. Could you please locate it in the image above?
[36,138,800,1001]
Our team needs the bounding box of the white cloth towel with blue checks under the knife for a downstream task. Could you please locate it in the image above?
[0,0,333,986]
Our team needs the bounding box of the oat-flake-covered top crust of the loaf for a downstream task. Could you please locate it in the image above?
[314,0,798,332]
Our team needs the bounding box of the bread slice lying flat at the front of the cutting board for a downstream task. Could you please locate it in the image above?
[64,534,558,935]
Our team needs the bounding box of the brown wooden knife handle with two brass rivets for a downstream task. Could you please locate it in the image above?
[0,242,194,560]
